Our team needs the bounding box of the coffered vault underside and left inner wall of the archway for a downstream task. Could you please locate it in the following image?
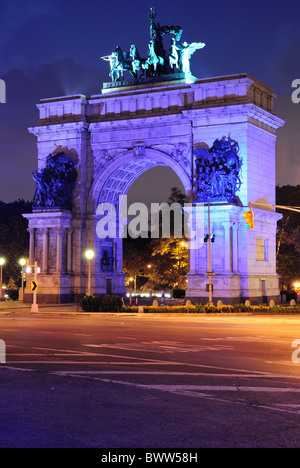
[94,149,191,297]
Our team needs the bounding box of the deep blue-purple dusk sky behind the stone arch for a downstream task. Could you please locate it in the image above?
[0,0,300,202]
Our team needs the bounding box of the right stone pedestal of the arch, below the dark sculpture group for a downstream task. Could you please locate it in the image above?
[186,204,281,304]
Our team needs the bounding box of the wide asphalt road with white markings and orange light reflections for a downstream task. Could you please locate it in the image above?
[0,314,300,449]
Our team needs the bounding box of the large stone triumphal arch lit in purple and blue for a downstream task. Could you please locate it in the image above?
[25,10,284,303]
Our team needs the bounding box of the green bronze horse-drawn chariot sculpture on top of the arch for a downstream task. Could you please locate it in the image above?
[101,7,205,82]
